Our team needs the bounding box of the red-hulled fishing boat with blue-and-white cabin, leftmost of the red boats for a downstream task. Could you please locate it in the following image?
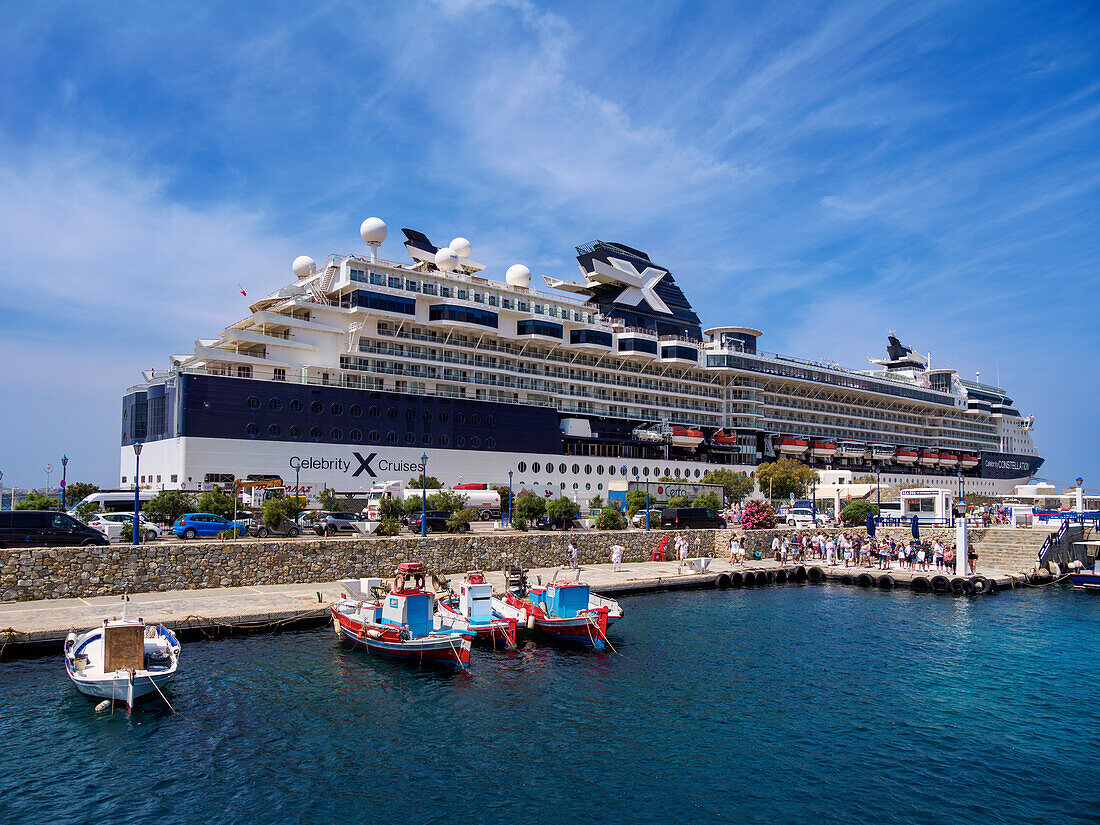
[331,562,474,670]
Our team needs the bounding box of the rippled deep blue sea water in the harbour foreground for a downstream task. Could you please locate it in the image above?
[0,585,1100,825]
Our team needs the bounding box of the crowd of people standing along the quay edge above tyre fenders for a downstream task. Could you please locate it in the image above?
[729,531,978,575]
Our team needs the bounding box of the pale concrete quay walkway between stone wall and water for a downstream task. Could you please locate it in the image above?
[0,559,1024,660]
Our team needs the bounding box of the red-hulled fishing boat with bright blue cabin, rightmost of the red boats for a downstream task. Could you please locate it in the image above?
[493,582,623,650]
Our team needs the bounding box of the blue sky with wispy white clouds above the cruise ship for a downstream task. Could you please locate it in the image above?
[0,0,1100,486]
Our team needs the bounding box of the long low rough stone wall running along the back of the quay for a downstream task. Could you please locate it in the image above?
[0,528,994,602]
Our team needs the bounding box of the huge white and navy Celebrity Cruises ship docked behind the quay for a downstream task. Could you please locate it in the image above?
[120,218,1043,502]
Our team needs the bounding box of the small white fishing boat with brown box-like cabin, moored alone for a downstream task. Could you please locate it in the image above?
[65,596,179,708]
